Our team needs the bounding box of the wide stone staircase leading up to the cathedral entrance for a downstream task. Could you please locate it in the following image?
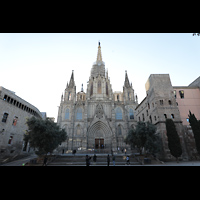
[47,154,140,166]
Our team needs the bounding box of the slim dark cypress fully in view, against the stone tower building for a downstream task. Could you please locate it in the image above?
[166,119,182,161]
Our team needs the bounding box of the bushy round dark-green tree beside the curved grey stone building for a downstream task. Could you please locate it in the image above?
[24,117,67,155]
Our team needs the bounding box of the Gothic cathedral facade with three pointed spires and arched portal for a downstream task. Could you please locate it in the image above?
[57,42,138,151]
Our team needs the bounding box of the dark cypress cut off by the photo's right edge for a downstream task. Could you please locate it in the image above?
[188,111,200,154]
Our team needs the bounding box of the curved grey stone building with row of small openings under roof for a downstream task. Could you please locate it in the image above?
[0,87,42,157]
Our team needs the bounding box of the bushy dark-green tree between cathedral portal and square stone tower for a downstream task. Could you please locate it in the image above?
[125,122,161,154]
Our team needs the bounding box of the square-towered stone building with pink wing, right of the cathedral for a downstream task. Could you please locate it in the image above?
[135,74,200,160]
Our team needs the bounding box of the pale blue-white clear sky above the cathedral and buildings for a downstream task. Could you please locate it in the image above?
[0,33,200,121]
